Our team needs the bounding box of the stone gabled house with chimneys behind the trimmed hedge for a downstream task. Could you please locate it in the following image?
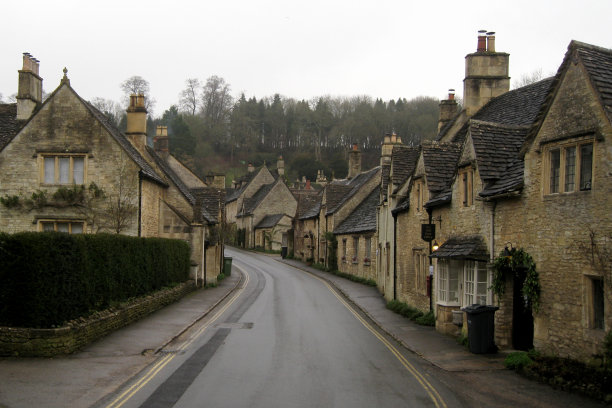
[0,54,222,281]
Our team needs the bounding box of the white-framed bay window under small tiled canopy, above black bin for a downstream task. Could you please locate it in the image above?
[438,259,493,306]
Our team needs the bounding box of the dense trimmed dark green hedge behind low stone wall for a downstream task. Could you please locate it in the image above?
[0,232,190,328]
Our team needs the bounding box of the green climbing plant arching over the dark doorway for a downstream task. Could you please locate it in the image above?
[491,248,540,313]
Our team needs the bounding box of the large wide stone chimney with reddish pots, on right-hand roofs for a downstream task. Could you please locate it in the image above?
[463,30,510,116]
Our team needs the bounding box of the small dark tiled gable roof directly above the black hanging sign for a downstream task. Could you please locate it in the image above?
[422,141,461,196]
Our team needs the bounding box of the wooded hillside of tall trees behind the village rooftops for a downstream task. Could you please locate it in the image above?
[92,76,439,183]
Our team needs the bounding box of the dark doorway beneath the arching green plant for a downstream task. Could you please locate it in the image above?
[512,268,533,351]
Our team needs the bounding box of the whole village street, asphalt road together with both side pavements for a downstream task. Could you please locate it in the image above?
[0,249,599,408]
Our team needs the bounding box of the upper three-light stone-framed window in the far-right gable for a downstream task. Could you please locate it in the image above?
[544,142,593,194]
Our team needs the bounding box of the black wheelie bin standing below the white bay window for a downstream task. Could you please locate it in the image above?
[461,305,499,354]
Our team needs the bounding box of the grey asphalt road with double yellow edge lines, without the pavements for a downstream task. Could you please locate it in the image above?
[100,249,461,408]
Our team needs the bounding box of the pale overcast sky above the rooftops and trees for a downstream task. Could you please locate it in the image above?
[0,0,612,116]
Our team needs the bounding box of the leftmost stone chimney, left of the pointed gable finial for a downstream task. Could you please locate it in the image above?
[17,52,42,120]
